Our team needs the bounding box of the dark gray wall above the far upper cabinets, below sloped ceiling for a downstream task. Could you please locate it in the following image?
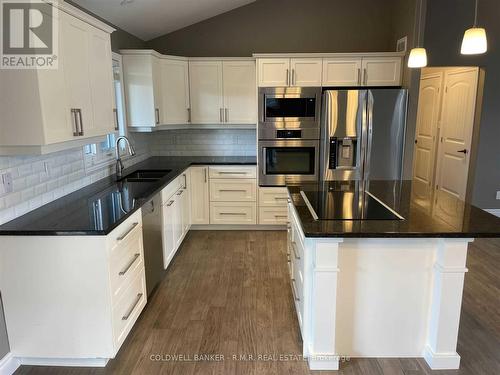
[148,0,396,56]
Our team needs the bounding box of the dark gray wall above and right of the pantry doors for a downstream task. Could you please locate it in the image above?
[425,0,500,208]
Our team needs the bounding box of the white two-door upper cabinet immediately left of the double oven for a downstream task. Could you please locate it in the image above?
[189,60,257,124]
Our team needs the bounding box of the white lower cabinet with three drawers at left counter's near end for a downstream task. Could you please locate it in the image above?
[0,210,147,366]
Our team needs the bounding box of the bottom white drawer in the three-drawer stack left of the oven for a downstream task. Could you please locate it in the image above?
[210,202,257,225]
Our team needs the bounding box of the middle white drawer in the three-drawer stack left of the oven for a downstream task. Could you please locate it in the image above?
[210,179,257,202]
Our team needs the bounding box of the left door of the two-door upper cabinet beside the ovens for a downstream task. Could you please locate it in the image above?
[189,61,224,124]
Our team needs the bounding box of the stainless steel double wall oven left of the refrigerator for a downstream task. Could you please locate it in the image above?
[258,87,321,186]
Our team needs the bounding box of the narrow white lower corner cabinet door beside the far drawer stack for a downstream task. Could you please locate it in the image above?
[189,166,210,225]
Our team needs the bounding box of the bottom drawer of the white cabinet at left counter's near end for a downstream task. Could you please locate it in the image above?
[112,268,147,351]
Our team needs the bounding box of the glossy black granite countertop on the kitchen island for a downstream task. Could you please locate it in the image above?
[287,181,500,238]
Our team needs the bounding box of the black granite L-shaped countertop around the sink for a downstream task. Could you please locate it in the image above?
[0,156,256,236]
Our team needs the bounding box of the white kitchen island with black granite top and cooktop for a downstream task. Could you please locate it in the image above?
[287,181,500,370]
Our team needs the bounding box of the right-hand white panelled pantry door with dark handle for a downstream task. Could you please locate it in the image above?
[436,68,479,200]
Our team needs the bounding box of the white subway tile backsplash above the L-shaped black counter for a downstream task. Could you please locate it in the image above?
[0,129,257,225]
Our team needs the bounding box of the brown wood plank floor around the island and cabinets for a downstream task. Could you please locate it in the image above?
[16,231,500,375]
